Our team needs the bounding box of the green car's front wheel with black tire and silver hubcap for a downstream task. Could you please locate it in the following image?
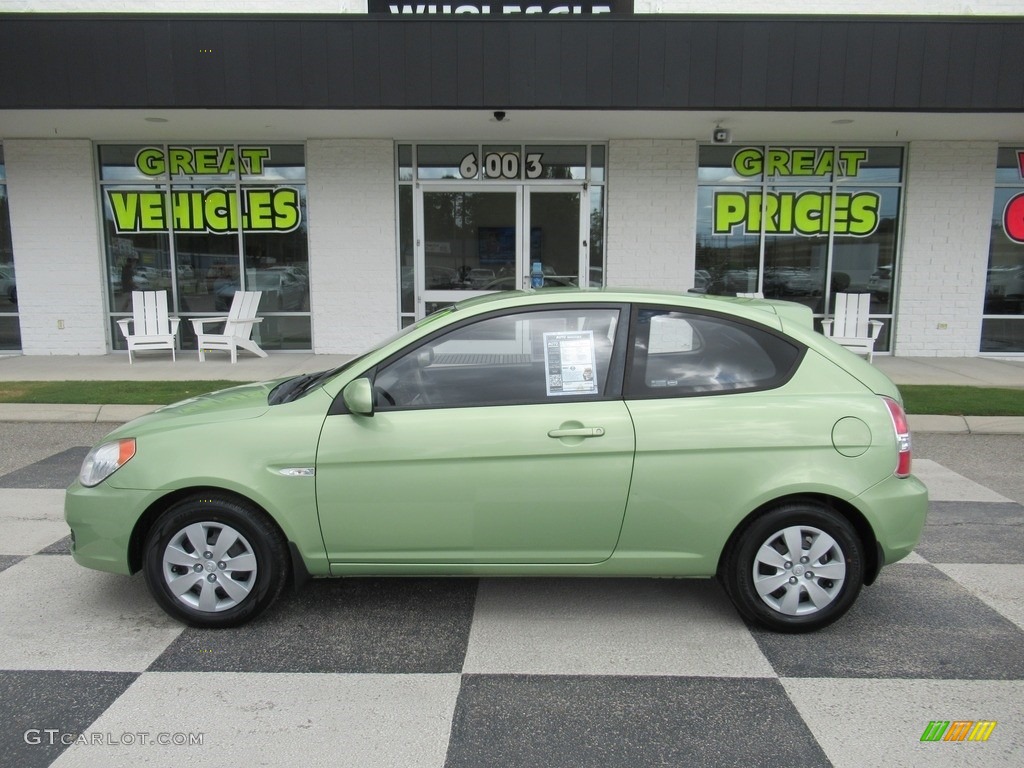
[142,495,289,629]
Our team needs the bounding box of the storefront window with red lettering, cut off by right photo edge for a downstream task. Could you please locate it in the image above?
[981,147,1024,354]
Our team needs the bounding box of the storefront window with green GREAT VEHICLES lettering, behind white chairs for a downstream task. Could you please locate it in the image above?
[99,144,312,350]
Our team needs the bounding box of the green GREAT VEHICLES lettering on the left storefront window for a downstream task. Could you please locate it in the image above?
[103,145,302,234]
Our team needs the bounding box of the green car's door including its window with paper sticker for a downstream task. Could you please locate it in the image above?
[316,304,634,563]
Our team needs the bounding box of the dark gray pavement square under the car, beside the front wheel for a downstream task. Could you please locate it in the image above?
[151,579,476,674]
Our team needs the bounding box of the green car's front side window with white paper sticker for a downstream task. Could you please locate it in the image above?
[374,307,618,411]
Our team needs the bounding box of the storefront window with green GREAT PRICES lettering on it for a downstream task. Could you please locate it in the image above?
[693,145,903,350]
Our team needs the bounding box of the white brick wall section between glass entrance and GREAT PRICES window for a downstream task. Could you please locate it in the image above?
[605,139,697,291]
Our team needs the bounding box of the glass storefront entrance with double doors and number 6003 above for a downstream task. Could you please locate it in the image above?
[395,142,607,326]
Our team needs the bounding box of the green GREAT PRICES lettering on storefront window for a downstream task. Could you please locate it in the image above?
[714,146,882,238]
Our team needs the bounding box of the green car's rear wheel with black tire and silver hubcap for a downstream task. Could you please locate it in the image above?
[720,504,864,633]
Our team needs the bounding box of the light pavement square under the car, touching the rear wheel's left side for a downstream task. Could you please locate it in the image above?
[464,579,774,677]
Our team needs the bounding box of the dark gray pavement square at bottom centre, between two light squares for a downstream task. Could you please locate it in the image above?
[445,675,828,768]
